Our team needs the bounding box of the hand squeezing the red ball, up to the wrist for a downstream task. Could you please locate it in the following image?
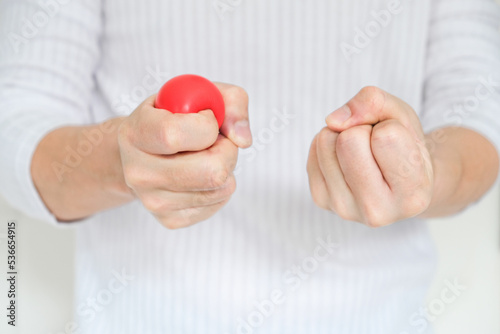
[118,84,252,228]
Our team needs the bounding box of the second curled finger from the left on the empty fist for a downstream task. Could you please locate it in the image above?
[316,128,359,220]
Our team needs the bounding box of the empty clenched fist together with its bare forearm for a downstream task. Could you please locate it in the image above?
[307,87,499,227]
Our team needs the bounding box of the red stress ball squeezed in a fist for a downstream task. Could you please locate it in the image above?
[155,74,225,129]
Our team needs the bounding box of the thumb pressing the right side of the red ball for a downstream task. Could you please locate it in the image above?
[214,82,252,148]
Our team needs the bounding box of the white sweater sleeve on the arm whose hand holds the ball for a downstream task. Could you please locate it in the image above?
[0,0,102,222]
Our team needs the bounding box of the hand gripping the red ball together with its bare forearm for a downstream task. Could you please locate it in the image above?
[31,83,252,228]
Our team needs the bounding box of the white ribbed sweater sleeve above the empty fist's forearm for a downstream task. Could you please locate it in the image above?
[421,0,500,157]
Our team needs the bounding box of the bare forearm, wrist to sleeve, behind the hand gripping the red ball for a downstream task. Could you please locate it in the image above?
[31,118,134,221]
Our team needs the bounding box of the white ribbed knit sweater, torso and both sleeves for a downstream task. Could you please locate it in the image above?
[0,0,500,334]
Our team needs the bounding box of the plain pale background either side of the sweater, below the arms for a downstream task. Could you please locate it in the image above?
[0,0,500,334]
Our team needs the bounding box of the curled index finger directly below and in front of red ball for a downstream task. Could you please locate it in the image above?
[127,96,219,154]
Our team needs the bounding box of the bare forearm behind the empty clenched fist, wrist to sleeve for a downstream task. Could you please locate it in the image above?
[421,127,499,218]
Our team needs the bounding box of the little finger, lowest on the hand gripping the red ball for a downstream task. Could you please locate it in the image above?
[155,199,229,229]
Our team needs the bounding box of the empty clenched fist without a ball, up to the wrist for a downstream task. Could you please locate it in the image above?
[307,87,434,227]
